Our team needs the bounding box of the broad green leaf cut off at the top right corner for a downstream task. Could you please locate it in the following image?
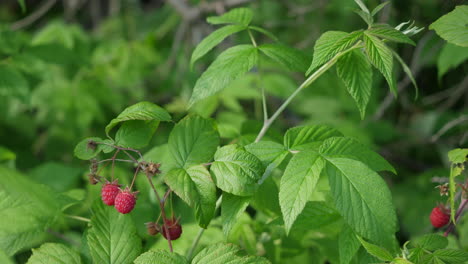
[429,5,468,47]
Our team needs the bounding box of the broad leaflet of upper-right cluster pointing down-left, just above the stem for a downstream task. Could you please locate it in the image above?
[306,31,362,75]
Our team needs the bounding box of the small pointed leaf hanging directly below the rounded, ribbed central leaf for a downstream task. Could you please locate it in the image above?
[221,192,251,237]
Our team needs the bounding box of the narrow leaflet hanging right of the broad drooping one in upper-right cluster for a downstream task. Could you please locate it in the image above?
[364,32,397,96]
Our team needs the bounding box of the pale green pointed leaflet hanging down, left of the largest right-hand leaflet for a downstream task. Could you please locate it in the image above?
[279,151,325,234]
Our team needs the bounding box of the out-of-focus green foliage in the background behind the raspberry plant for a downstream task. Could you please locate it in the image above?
[0,0,468,263]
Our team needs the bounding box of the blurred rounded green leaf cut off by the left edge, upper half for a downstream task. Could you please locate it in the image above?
[0,64,29,102]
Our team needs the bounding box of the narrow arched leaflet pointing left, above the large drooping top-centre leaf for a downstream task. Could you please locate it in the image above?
[190,25,246,67]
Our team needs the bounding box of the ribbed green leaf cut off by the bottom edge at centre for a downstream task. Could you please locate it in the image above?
[192,243,270,264]
